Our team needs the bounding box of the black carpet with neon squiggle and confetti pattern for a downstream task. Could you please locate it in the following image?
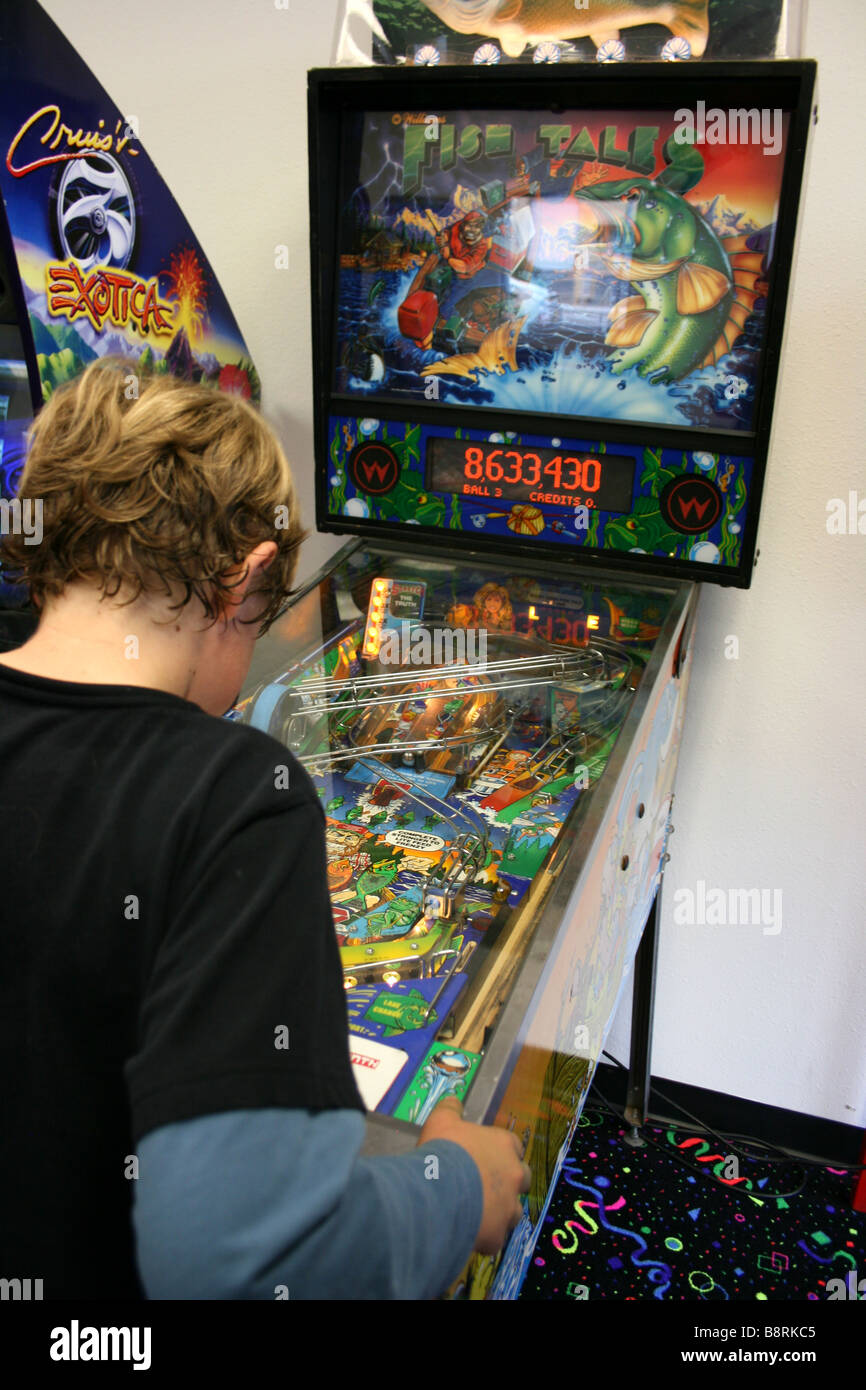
[520,1102,866,1302]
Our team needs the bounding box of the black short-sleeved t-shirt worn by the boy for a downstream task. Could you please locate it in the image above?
[0,666,364,1298]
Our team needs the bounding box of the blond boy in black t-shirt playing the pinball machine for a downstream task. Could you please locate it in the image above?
[0,363,528,1298]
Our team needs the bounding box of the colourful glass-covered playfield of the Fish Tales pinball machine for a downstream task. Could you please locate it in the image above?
[232,542,671,1123]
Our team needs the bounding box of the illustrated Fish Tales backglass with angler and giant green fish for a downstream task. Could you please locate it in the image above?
[334,110,787,432]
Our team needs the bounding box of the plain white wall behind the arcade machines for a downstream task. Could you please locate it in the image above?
[44,0,866,1125]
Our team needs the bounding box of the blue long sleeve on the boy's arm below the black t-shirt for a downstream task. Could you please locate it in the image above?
[133,1109,484,1300]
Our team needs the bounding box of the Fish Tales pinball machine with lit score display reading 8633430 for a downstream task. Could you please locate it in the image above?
[239,63,815,1298]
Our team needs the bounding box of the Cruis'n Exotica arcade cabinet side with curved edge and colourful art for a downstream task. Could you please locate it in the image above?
[0,0,260,605]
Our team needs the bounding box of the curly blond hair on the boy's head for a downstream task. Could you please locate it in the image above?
[3,359,304,632]
